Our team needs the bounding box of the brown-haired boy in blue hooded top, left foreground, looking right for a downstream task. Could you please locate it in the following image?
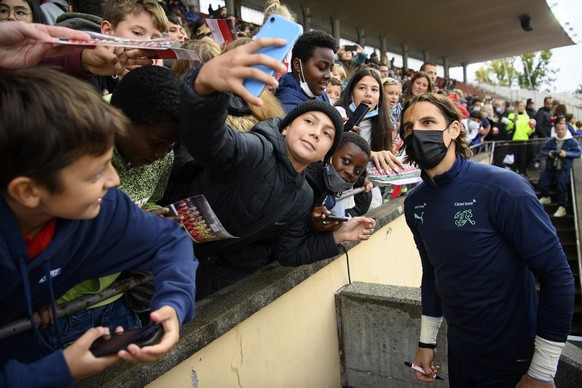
[0,68,198,387]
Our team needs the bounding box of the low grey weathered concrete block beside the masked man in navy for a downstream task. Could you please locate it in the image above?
[336,282,448,388]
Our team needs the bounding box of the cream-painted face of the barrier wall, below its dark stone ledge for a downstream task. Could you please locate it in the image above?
[144,200,420,387]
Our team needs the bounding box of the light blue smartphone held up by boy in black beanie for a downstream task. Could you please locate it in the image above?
[243,15,303,97]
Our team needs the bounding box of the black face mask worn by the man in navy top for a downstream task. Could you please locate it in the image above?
[404,127,448,170]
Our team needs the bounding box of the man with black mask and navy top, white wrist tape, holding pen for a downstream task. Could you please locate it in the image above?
[402,94,574,387]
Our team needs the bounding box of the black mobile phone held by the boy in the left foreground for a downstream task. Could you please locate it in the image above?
[89,324,164,357]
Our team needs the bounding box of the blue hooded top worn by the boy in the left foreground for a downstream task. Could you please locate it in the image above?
[0,189,198,387]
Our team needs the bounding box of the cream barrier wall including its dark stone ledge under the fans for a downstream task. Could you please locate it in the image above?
[79,198,421,388]
